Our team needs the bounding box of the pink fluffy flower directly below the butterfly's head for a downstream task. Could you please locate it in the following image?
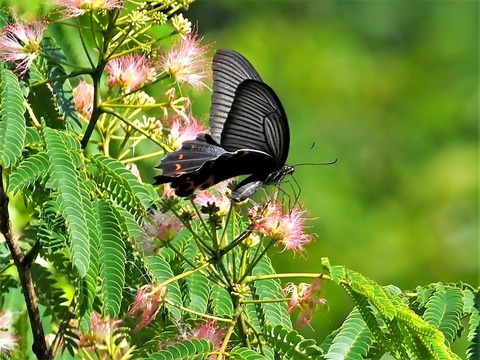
[249,197,312,251]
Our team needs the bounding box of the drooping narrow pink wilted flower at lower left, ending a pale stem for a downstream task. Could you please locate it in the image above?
[128,285,168,330]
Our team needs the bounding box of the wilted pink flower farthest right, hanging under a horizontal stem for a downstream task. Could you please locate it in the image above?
[283,278,327,326]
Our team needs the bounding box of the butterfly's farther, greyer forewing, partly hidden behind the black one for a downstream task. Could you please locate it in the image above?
[210,49,262,144]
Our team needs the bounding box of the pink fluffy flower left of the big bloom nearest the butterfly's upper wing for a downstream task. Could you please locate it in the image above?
[105,54,155,93]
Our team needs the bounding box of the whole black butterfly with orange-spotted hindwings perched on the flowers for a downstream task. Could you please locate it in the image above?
[154,49,294,202]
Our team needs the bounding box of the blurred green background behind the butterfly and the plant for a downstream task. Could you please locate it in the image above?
[3,0,480,356]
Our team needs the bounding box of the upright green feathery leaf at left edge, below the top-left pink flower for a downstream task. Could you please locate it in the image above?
[0,69,26,168]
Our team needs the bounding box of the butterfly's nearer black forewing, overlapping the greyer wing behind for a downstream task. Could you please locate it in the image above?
[220,80,290,165]
